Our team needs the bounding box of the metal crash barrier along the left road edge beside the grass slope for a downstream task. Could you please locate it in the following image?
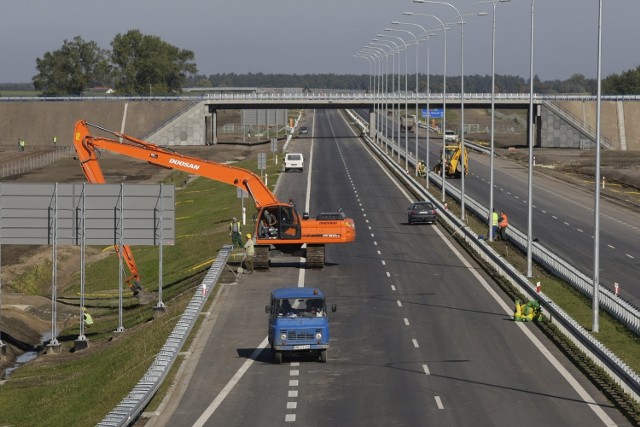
[97,245,233,427]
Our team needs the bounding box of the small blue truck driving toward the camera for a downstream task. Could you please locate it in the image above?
[265,288,336,363]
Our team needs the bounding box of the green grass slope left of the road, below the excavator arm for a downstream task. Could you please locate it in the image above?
[0,159,280,426]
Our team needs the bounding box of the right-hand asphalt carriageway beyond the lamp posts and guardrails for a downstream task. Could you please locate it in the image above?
[370,112,640,307]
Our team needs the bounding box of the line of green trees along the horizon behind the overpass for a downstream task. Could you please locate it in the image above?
[0,30,640,96]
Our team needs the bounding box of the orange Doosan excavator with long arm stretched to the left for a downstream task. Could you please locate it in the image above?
[73,120,356,293]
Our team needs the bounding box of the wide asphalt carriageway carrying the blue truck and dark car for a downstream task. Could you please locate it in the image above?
[147,110,629,426]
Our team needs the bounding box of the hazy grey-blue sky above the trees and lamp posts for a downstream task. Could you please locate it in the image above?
[0,0,640,83]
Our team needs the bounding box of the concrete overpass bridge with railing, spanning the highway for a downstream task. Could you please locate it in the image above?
[202,91,640,149]
